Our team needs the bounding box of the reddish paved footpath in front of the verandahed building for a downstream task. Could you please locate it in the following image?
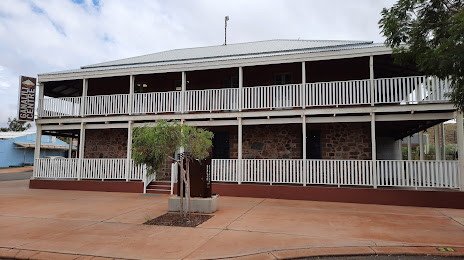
[0,180,464,260]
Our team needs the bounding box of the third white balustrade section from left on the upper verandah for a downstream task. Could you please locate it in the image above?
[133,91,181,114]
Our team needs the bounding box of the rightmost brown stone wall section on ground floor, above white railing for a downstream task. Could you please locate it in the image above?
[319,123,372,160]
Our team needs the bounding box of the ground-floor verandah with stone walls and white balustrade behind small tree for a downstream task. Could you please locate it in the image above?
[35,122,459,188]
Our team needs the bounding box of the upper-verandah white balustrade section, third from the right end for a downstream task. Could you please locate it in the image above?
[243,84,301,109]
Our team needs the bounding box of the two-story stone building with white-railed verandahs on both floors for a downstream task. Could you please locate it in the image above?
[31,40,464,207]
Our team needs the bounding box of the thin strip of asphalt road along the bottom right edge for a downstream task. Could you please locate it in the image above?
[298,255,464,260]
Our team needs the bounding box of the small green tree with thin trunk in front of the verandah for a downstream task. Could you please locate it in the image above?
[132,121,213,216]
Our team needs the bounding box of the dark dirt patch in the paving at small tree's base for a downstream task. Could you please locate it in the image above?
[144,213,213,227]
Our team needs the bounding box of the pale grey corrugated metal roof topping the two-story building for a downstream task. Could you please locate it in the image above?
[39,40,385,75]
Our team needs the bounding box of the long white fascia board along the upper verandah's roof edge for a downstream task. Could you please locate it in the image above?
[38,46,392,83]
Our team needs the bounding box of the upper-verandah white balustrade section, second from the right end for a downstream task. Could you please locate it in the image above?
[305,80,371,107]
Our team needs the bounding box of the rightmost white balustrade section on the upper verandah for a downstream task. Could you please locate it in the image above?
[374,76,451,104]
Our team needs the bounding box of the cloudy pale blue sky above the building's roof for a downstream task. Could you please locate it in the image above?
[0,0,396,127]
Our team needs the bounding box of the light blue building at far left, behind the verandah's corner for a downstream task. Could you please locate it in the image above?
[0,132,69,168]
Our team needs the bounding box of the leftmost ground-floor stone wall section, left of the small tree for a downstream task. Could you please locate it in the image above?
[84,129,127,158]
